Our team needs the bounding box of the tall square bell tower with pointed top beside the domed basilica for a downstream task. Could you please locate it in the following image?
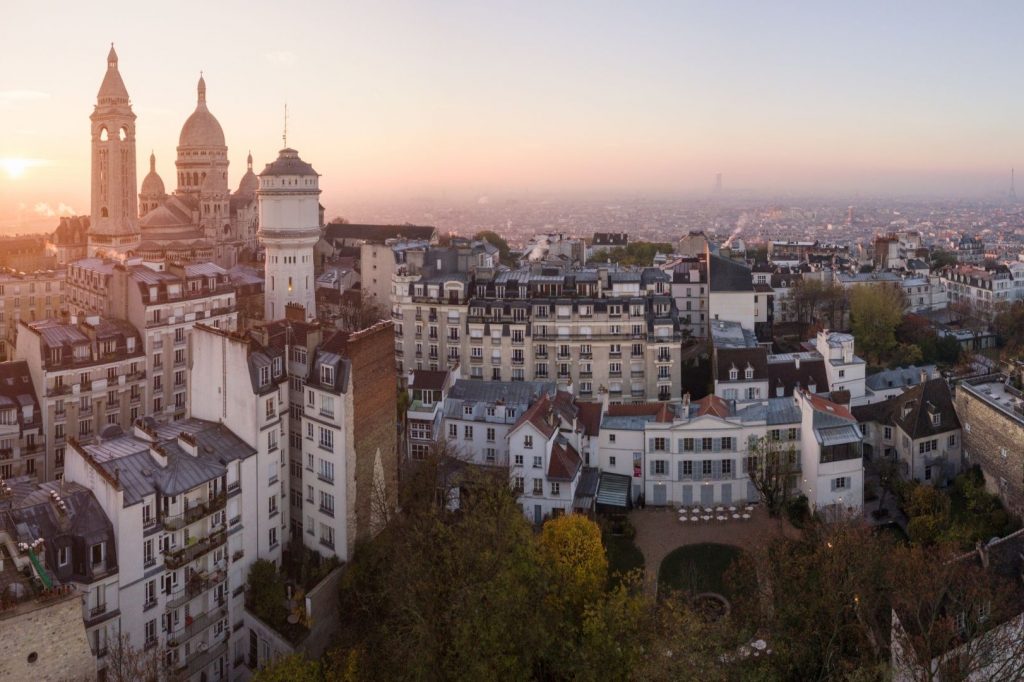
[88,45,141,259]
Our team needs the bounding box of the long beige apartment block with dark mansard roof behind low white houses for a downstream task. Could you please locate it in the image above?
[393,251,682,402]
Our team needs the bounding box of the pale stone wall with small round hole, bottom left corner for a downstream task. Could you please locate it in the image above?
[0,593,96,682]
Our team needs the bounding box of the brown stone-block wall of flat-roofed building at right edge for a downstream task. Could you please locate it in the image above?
[955,388,1024,514]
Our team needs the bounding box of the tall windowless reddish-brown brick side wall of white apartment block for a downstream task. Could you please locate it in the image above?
[345,321,398,545]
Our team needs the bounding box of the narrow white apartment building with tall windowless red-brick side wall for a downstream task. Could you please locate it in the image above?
[297,322,398,560]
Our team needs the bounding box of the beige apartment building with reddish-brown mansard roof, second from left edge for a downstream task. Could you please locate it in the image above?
[15,315,146,480]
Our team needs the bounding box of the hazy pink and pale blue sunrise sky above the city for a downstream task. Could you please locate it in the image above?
[0,0,1024,231]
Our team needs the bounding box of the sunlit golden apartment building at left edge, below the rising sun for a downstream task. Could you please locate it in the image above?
[0,269,67,360]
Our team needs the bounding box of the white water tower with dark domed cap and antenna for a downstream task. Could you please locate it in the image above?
[256,147,321,322]
